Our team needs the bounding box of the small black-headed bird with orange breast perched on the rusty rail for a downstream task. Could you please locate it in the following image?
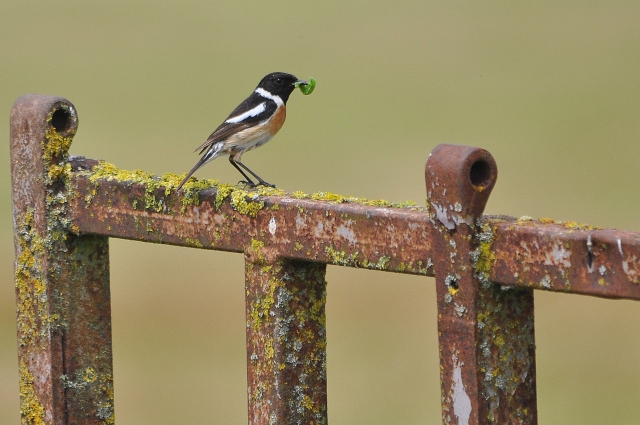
[176,72,309,190]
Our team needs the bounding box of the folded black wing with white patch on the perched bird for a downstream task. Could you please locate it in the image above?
[196,92,278,154]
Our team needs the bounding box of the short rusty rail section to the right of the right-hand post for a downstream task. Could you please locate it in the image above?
[486,217,640,299]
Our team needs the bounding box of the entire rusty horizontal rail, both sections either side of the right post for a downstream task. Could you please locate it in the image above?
[70,158,640,299]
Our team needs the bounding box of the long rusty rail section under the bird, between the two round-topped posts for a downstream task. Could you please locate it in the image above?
[71,159,433,275]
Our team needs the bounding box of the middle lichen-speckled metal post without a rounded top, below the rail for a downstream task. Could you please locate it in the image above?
[245,240,327,425]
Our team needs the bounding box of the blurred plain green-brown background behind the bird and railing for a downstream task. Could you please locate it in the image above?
[0,0,640,425]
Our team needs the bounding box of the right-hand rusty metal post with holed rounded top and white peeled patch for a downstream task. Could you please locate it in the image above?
[426,145,537,425]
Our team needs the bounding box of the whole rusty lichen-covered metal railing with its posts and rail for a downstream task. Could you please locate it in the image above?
[11,95,640,424]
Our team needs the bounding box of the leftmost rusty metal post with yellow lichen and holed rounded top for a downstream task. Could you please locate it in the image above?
[11,95,114,425]
